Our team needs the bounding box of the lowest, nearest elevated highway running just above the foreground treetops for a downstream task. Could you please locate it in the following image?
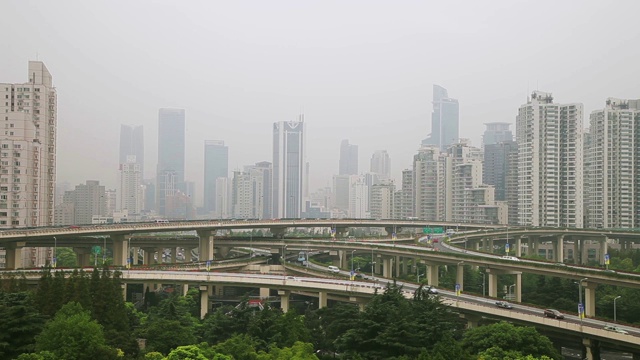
[6,270,640,354]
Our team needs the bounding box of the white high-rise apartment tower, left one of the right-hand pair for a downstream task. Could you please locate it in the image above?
[516,91,583,228]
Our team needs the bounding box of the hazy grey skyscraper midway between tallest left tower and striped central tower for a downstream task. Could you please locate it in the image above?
[204,140,229,213]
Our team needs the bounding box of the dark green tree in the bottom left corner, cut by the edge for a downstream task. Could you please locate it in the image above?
[0,292,45,359]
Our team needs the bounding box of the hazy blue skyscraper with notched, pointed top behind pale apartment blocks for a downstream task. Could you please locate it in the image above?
[422,85,460,151]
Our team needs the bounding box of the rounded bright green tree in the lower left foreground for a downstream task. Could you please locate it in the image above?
[36,302,118,360]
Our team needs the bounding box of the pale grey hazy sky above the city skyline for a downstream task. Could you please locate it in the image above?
[0,0,640,204]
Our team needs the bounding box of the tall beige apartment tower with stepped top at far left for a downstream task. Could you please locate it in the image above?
[0,61,58,228]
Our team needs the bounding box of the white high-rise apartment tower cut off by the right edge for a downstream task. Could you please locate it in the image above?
[584,98,640,228]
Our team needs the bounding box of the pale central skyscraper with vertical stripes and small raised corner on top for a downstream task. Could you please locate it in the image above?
[273,115,306,218]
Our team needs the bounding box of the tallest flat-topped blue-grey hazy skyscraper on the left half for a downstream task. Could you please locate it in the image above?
[156,109,185,215]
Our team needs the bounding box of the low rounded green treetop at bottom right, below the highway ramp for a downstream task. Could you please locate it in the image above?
[462,321,562,359]
